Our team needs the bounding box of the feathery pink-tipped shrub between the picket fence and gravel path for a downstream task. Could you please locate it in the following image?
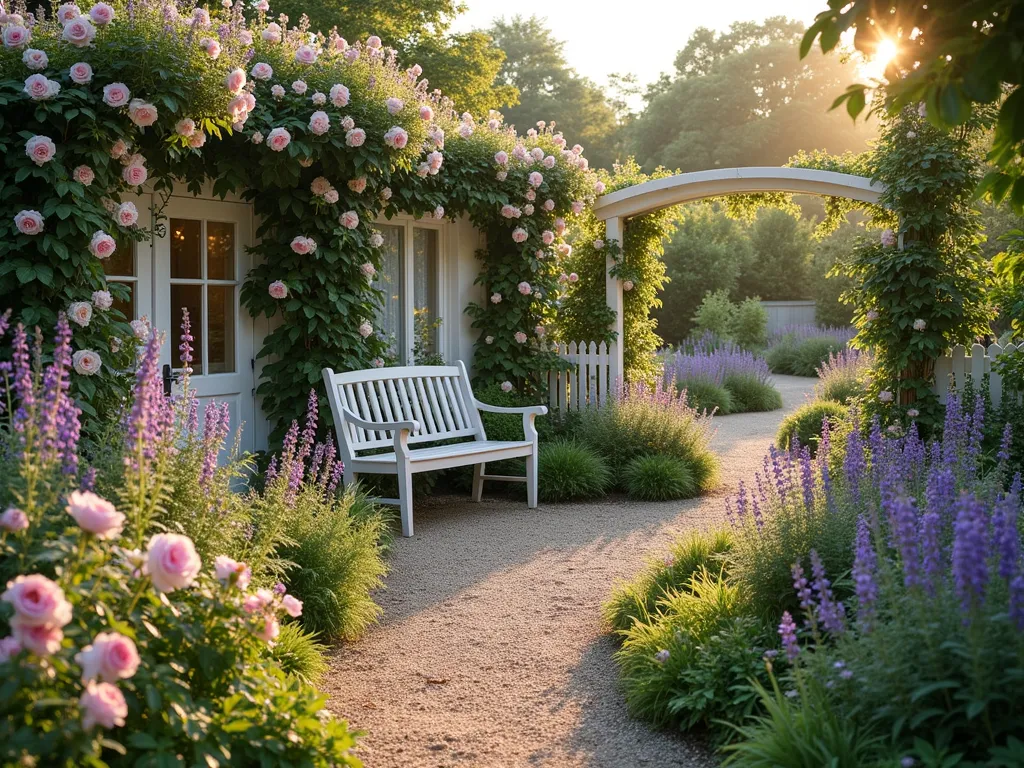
[574,383,718,490]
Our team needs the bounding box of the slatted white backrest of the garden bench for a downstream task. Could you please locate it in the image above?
[324,361,484,461]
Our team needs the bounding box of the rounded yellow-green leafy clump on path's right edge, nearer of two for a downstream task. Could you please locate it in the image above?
[615,568,773,741]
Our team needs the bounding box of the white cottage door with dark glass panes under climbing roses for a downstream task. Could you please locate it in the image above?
[152,197,256,451]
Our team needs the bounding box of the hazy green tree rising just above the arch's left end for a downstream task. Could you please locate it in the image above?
[488,15,617,168]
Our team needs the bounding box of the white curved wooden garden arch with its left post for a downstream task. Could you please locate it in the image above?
[594,168,885,381]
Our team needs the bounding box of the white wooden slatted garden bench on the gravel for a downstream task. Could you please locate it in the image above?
[323,360,548,536]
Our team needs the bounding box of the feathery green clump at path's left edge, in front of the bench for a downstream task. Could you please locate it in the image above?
[276,486,390,640]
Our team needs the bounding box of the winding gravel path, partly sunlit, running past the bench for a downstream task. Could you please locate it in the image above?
[324,376,813,768]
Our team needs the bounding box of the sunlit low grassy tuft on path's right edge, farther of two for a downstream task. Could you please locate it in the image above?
[602,528,732,632]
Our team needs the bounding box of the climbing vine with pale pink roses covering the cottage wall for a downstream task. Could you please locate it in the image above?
[0,0,596,439]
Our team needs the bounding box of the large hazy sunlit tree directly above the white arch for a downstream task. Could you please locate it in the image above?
[627,16,874,171]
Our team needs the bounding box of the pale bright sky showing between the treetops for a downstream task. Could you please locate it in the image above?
[455,0,827,91]
